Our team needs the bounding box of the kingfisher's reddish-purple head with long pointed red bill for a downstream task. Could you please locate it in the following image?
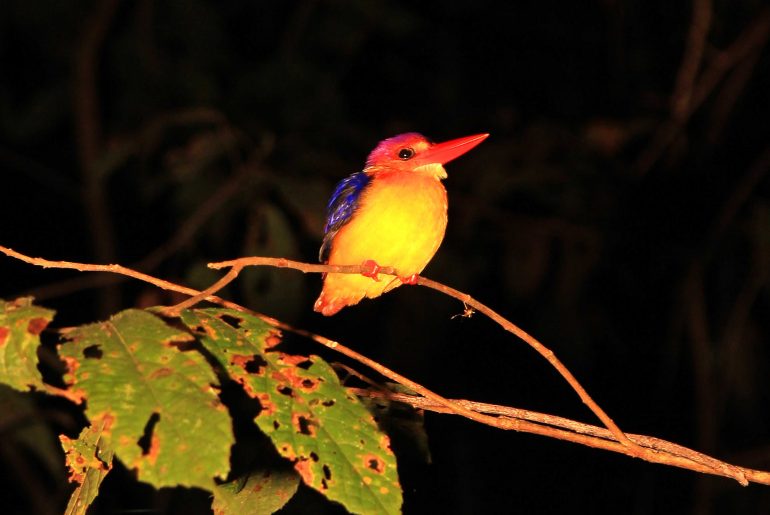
[364,132,489,179]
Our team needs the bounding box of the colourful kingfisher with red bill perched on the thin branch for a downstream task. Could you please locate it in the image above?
[313,132,489,316]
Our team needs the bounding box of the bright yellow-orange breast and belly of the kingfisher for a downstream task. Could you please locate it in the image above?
[315,172,447,315]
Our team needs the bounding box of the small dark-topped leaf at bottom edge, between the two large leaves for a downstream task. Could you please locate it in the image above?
[211,469,299,515]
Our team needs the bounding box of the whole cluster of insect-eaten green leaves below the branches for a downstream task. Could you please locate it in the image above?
[0,299,402,514]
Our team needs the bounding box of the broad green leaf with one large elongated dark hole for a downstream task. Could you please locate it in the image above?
[60,309,233,490]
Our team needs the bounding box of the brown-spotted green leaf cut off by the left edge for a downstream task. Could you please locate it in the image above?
[0,297,54,392]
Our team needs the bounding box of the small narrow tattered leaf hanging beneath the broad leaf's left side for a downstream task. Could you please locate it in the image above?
[59,419,114,515]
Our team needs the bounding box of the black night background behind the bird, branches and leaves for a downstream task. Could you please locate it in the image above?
[0,0,770,514]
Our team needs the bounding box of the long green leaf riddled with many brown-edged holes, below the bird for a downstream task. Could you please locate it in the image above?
[182,309,402,513]
